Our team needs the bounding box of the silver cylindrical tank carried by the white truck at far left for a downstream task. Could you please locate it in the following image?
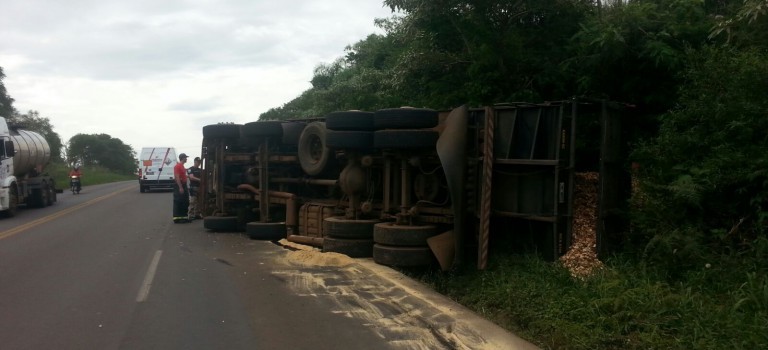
[11,130,51,177]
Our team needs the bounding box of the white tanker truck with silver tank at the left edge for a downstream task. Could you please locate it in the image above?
[0,118,61,216]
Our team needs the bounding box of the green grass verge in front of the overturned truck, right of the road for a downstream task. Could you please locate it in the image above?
[404,241,768,349]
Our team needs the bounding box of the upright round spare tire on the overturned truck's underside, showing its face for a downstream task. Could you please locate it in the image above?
[298,122,331,176]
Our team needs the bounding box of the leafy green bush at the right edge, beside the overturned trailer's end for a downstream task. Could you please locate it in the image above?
[633,48,768,268]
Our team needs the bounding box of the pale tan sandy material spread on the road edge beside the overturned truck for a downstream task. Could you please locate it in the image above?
[273,240,537,350]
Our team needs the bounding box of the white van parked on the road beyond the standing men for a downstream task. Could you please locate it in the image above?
[139,147,178,193]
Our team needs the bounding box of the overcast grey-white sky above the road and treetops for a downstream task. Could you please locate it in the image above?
[0,0,392,161]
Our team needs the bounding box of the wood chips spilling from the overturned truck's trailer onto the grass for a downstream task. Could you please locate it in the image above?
[560,172,603,277]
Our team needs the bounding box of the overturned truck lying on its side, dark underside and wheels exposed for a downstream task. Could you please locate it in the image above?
[198,101,577,269]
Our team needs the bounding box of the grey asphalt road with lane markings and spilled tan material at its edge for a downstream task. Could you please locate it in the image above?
[0,182,532,350]
